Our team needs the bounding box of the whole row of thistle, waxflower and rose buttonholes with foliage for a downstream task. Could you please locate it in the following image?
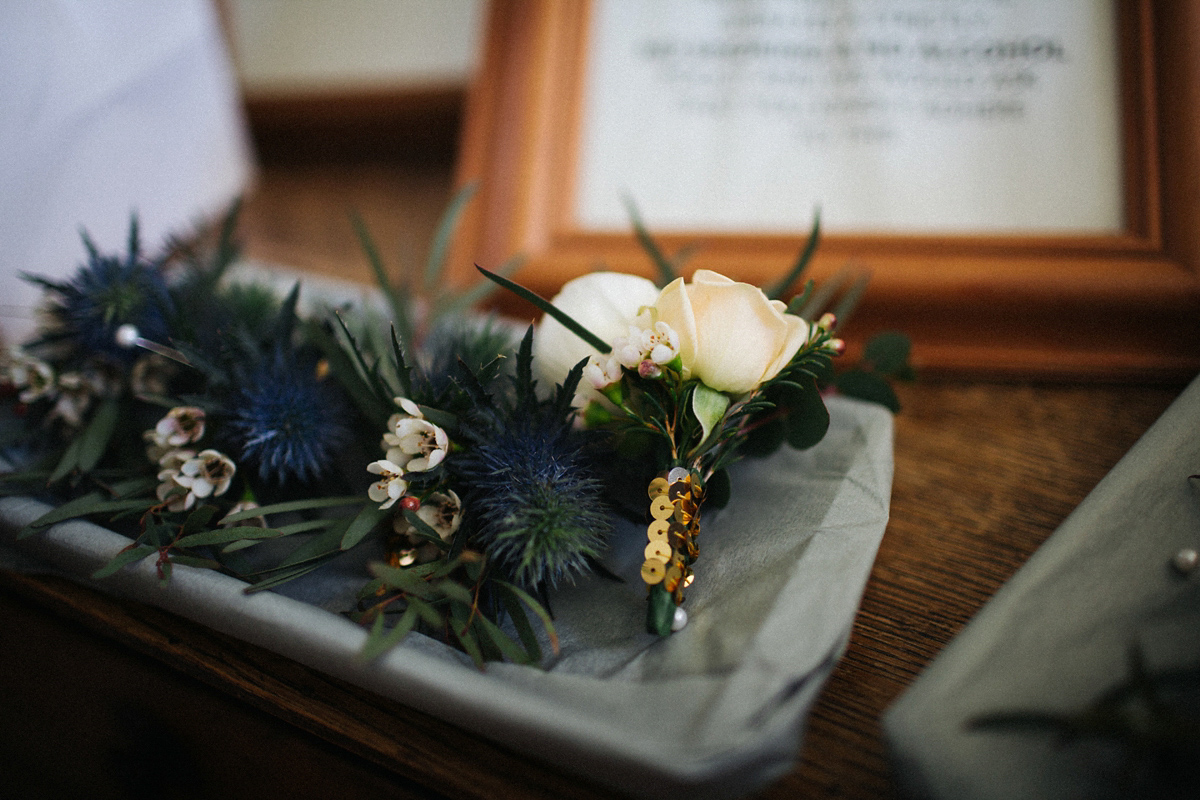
[0,191,907,664]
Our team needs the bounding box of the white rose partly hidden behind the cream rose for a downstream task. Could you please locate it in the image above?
[533,272,659,404]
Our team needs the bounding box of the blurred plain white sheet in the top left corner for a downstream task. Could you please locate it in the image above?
[0,0,251,344]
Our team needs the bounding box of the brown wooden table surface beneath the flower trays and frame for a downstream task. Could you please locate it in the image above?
[0,158,1183,800]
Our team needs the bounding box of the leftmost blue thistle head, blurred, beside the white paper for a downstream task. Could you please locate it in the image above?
[24,217,173,365]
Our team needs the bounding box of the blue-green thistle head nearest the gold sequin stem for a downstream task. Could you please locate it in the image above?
[460,426,611,588]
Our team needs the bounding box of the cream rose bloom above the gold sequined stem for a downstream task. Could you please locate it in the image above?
[652,270,809,395]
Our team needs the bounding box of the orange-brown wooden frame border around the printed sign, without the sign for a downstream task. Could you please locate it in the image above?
[452,0,1200,380]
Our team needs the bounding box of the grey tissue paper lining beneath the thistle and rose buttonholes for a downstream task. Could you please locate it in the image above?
[0,398,892,798]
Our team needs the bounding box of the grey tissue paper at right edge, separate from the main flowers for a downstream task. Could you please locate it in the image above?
[883,379,1200,800]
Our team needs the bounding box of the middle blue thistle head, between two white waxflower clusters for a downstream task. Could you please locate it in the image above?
[228,351,350,486]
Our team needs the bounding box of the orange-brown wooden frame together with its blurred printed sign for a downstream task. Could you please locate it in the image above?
[455,0,1200,378]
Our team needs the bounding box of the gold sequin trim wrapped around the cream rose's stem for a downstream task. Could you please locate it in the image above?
[642,467,704,606]
